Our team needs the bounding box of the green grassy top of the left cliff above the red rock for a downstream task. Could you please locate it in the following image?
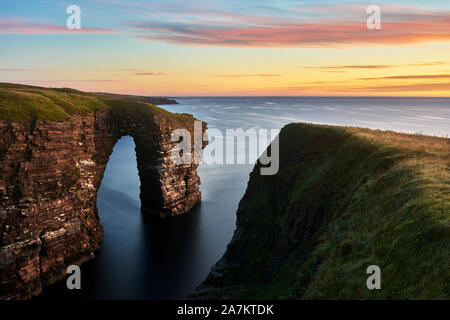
[0,83,188,120]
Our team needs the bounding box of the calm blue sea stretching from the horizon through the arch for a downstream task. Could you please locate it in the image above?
[40,97,450,299]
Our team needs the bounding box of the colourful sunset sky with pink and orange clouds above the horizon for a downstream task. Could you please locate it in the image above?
[0,0,450,97]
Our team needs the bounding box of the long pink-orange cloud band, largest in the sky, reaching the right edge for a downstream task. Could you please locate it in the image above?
[134,21,450,47]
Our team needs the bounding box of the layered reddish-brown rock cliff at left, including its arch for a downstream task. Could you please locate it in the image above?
[0,109,205,299]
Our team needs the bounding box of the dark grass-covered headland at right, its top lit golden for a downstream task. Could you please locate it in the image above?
[198,124,450,299]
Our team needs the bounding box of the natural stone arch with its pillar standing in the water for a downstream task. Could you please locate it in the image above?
[96,111,207,217]
